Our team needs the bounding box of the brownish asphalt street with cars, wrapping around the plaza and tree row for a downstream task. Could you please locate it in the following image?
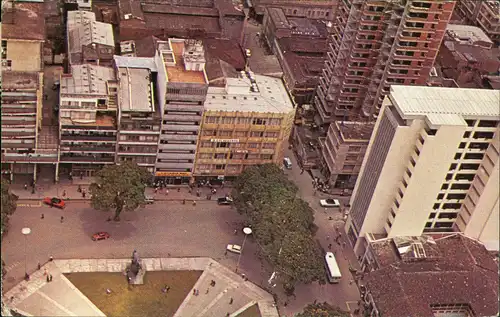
[2,151,359,316]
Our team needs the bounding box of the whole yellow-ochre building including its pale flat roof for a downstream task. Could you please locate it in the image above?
[194,72,294,180]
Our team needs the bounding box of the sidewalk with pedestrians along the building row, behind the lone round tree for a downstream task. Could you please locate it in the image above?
[10,179,231,201]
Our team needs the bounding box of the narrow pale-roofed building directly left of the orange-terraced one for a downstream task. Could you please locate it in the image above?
[115,56,161,174]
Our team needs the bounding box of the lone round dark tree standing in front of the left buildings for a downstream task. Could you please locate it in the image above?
[89,162,150,221]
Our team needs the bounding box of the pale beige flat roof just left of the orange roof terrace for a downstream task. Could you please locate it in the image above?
[118,68,154,112]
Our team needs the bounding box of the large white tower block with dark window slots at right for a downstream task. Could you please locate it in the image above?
[345,86,500,255]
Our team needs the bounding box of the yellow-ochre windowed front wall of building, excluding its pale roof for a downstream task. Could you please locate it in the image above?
[195,110,294,177]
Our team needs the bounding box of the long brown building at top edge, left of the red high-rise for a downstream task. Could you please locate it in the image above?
[252,0,338,21]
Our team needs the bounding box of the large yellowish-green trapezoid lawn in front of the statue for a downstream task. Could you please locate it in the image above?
[64,271,201,317]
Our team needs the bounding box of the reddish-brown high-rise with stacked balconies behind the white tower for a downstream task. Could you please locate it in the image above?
[314,0,455,123]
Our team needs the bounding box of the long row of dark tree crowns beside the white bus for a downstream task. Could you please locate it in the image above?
[233,164,326,286]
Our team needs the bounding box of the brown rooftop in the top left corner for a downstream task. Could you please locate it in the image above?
[2,1,45,41]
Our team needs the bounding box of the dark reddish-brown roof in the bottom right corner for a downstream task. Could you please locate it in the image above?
[363,234,498,317]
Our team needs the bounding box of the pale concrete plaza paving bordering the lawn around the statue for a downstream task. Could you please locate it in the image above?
[5,258,279,317]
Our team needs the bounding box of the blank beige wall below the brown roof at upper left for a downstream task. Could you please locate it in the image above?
[2,40,43,72]
